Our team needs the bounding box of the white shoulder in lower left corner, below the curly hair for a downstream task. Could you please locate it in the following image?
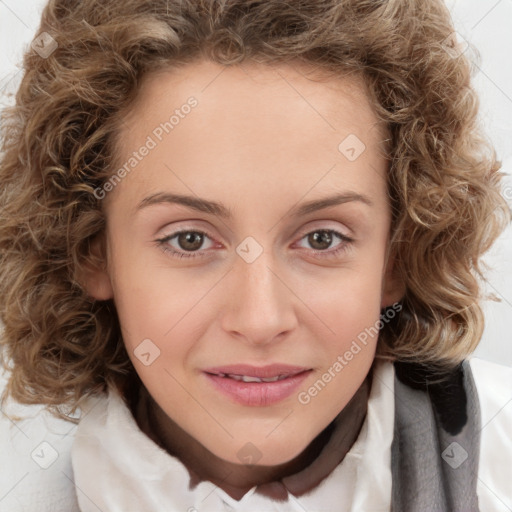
[0,366,79,512]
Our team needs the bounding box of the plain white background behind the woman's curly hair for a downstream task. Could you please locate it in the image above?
[0,0,512,366]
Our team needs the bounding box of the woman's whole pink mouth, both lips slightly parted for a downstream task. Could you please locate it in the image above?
[203,364,313,407]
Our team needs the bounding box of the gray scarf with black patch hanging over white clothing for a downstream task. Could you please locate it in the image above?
[391,361,480,512]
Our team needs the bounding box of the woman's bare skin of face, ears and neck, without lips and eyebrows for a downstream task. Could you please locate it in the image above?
[86,61,403,498]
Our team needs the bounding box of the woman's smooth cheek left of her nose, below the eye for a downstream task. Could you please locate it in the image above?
[108,252,215,388]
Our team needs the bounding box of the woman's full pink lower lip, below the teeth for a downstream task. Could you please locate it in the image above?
[205,370,311,407]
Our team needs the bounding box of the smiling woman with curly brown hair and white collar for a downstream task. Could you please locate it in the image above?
[0,0,512,511]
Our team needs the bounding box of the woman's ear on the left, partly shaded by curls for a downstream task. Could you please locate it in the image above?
[80,234,114,300]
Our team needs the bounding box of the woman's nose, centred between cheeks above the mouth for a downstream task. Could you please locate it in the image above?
[221,252,299,345]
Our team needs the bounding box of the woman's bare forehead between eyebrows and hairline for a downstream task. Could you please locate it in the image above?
[107,61,387,212]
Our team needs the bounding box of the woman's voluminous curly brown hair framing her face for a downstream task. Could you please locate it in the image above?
[0,0,510,417]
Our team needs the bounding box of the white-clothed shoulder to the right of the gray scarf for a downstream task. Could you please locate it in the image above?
[469,357,512,512]
